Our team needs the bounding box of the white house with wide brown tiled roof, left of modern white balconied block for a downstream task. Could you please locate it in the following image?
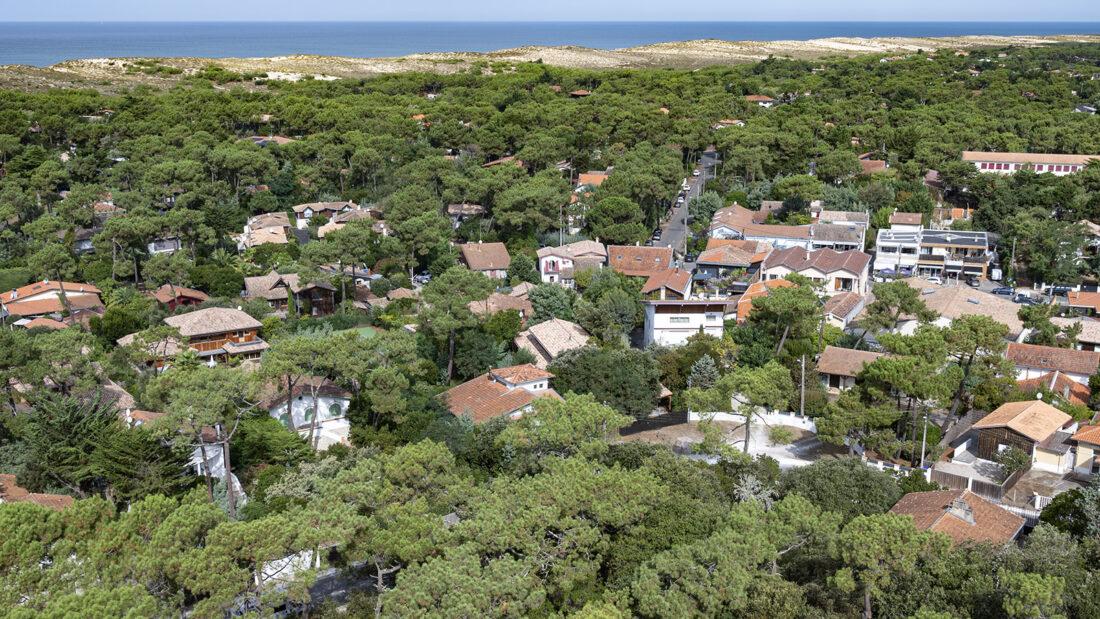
[760,247,871,296]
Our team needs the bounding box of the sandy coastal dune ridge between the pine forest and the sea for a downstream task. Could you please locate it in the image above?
[0,34,1100,89]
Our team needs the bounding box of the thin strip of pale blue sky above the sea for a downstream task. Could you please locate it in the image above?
[8,0,1100,22]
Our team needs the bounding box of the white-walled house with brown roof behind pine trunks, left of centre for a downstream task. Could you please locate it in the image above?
[256,376,352,451]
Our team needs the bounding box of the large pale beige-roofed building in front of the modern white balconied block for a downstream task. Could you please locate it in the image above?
[897,277,1024,342]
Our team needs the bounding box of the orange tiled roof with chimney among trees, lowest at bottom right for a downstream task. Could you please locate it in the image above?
[890,489,1026,544]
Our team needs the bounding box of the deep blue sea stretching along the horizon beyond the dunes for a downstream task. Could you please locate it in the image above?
[0,22,1100,66]
